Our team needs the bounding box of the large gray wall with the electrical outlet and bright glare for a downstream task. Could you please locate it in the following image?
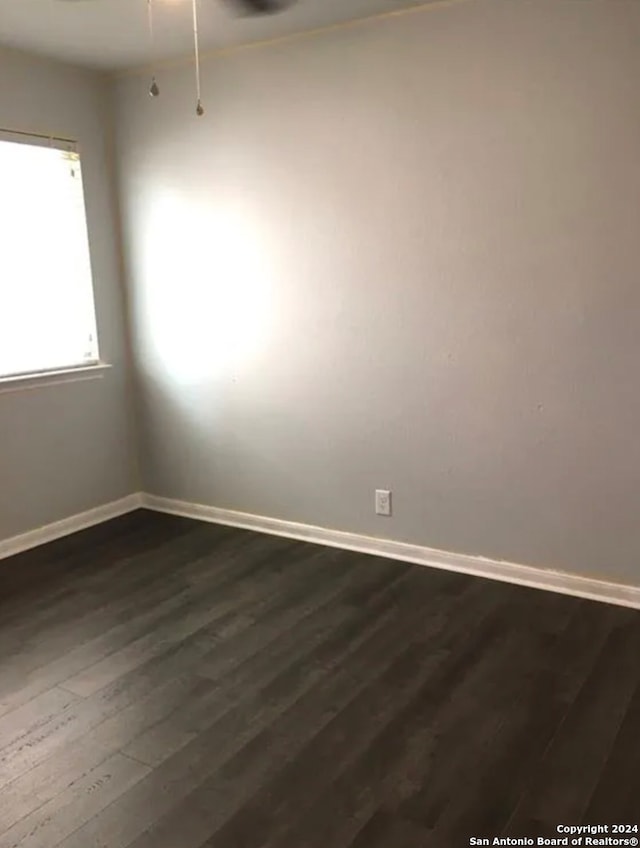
[117,0,640,583]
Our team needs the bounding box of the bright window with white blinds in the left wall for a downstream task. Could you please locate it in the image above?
[0,134,99,378]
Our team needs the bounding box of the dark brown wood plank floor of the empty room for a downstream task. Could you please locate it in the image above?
[0,511,640,848]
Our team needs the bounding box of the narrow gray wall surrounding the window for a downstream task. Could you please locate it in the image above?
[0,50,138,539]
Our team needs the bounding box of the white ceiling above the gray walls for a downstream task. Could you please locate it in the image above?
[0,0,437,70]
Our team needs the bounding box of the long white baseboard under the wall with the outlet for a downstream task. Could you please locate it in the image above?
[142,494,640,609]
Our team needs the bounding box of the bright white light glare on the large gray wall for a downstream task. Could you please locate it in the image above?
[142,194,272,382]
